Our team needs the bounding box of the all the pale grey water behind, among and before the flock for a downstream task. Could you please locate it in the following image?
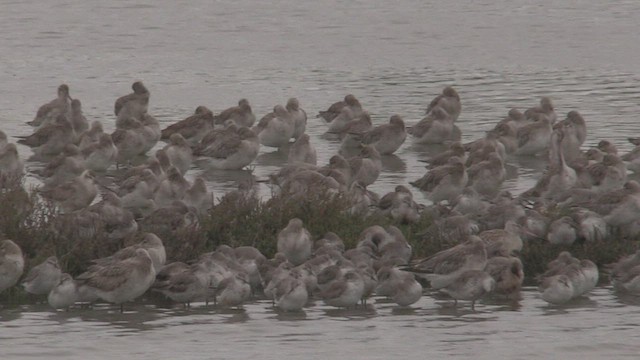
[0,0,640,359]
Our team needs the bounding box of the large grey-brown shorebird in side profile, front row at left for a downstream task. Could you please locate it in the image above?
[77,248,156,312]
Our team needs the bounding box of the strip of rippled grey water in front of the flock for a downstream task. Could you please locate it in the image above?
[0,286,640,359]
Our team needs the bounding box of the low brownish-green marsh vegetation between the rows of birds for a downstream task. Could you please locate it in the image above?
[0,176,638,306]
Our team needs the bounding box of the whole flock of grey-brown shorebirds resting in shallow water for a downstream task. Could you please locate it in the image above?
[0,81,640,311]
